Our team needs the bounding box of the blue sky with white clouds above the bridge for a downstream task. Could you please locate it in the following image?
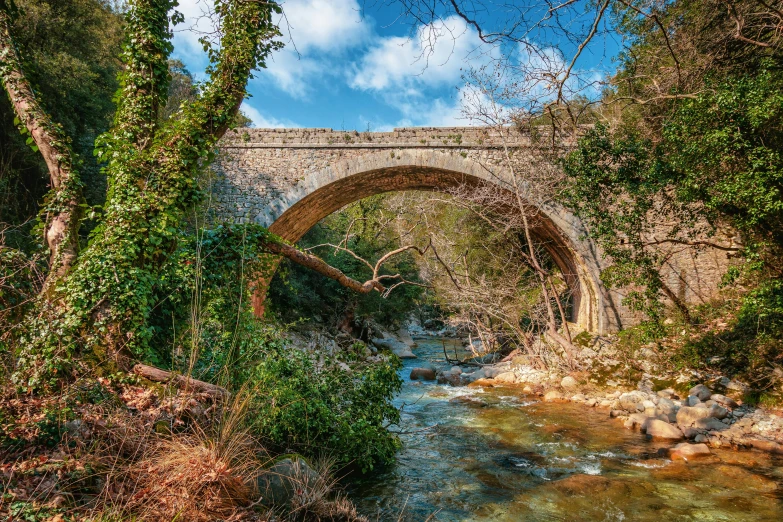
[174,0,616,131]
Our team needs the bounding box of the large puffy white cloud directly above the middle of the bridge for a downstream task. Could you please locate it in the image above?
[350,17,488,94]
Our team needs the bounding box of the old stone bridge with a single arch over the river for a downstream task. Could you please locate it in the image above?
[212,127,726,333]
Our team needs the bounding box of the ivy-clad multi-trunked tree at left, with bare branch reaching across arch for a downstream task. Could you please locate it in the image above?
[0,0,434,386]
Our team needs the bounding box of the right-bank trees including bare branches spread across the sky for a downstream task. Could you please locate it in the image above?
[392,0,783,320]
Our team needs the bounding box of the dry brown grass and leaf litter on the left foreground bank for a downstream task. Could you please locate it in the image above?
[0,372,367,522]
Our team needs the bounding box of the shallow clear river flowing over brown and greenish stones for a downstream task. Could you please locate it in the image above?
[349,339,783,522]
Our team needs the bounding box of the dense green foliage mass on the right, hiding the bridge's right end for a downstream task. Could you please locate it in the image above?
[564,0,783,335]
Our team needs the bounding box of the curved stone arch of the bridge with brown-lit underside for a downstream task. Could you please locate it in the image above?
[256,149,621,334]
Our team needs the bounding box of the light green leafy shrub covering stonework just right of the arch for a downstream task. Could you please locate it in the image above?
[563,125,687,319]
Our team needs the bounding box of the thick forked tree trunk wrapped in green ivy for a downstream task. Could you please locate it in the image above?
[2,0,278,386]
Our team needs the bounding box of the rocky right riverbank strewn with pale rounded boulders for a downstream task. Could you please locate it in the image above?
[422,344,783,454]
